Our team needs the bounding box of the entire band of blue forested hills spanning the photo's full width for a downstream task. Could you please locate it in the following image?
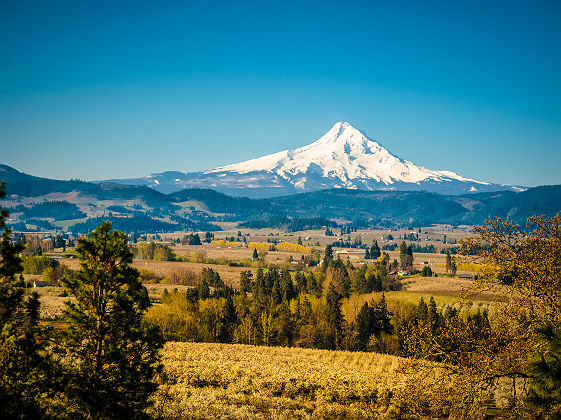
[0,165,561,230]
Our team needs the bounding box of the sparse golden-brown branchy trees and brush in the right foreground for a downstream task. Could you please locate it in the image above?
[396,215,561,418]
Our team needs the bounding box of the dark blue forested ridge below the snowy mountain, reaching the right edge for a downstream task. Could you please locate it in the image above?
[170,185,561,226]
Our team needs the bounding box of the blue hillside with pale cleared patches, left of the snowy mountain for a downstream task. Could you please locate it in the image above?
[0,165,220,233]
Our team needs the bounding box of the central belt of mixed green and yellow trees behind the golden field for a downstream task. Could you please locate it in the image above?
[148,246,400,350]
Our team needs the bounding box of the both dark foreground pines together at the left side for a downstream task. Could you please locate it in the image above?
[0,180,162,418]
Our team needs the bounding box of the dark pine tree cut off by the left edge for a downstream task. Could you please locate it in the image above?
[0,183,49,419]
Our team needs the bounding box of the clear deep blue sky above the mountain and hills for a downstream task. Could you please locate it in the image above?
[0,0,561,186]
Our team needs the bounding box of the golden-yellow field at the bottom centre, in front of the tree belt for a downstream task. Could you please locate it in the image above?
[153,342,405,418]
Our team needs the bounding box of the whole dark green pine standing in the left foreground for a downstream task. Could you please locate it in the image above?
[60,222,163,418]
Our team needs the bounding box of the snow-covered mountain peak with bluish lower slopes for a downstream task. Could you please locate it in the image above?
[106,122,520,197]
